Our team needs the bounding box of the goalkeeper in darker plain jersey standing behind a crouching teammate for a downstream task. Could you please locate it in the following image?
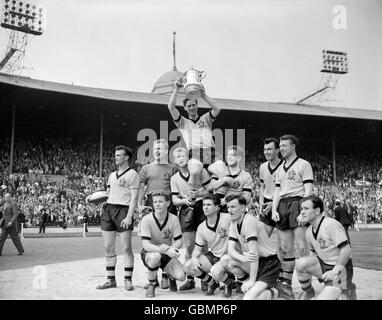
[138,139,177,289]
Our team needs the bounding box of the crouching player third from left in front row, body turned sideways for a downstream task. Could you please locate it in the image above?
[213,194,280,300]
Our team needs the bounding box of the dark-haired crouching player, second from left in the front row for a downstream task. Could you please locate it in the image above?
[183,194,232,296]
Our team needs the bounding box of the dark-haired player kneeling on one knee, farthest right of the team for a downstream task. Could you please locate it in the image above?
[296,196,356,300]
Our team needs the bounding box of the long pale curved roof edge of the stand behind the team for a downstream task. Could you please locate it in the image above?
[0,73,382,120]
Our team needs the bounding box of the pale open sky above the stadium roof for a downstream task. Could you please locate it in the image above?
[0,0,382,111]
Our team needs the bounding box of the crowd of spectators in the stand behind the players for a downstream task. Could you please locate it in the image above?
[0,138,382,227]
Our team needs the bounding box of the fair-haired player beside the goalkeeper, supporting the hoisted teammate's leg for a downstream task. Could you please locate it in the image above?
[170,147,211,291]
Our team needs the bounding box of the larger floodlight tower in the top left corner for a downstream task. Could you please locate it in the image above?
[0,0,46,75]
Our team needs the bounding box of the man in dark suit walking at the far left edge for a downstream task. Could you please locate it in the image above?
[0,193,24,256]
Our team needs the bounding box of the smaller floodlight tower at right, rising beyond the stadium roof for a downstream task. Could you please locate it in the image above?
[297,50,349,105]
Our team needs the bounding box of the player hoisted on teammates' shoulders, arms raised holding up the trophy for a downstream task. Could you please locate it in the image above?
[168,77,226,194]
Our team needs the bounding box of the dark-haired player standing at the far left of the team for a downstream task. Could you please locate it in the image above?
[97,145,139,291]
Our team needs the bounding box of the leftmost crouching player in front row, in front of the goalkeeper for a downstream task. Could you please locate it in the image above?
[141,191,186,298]
